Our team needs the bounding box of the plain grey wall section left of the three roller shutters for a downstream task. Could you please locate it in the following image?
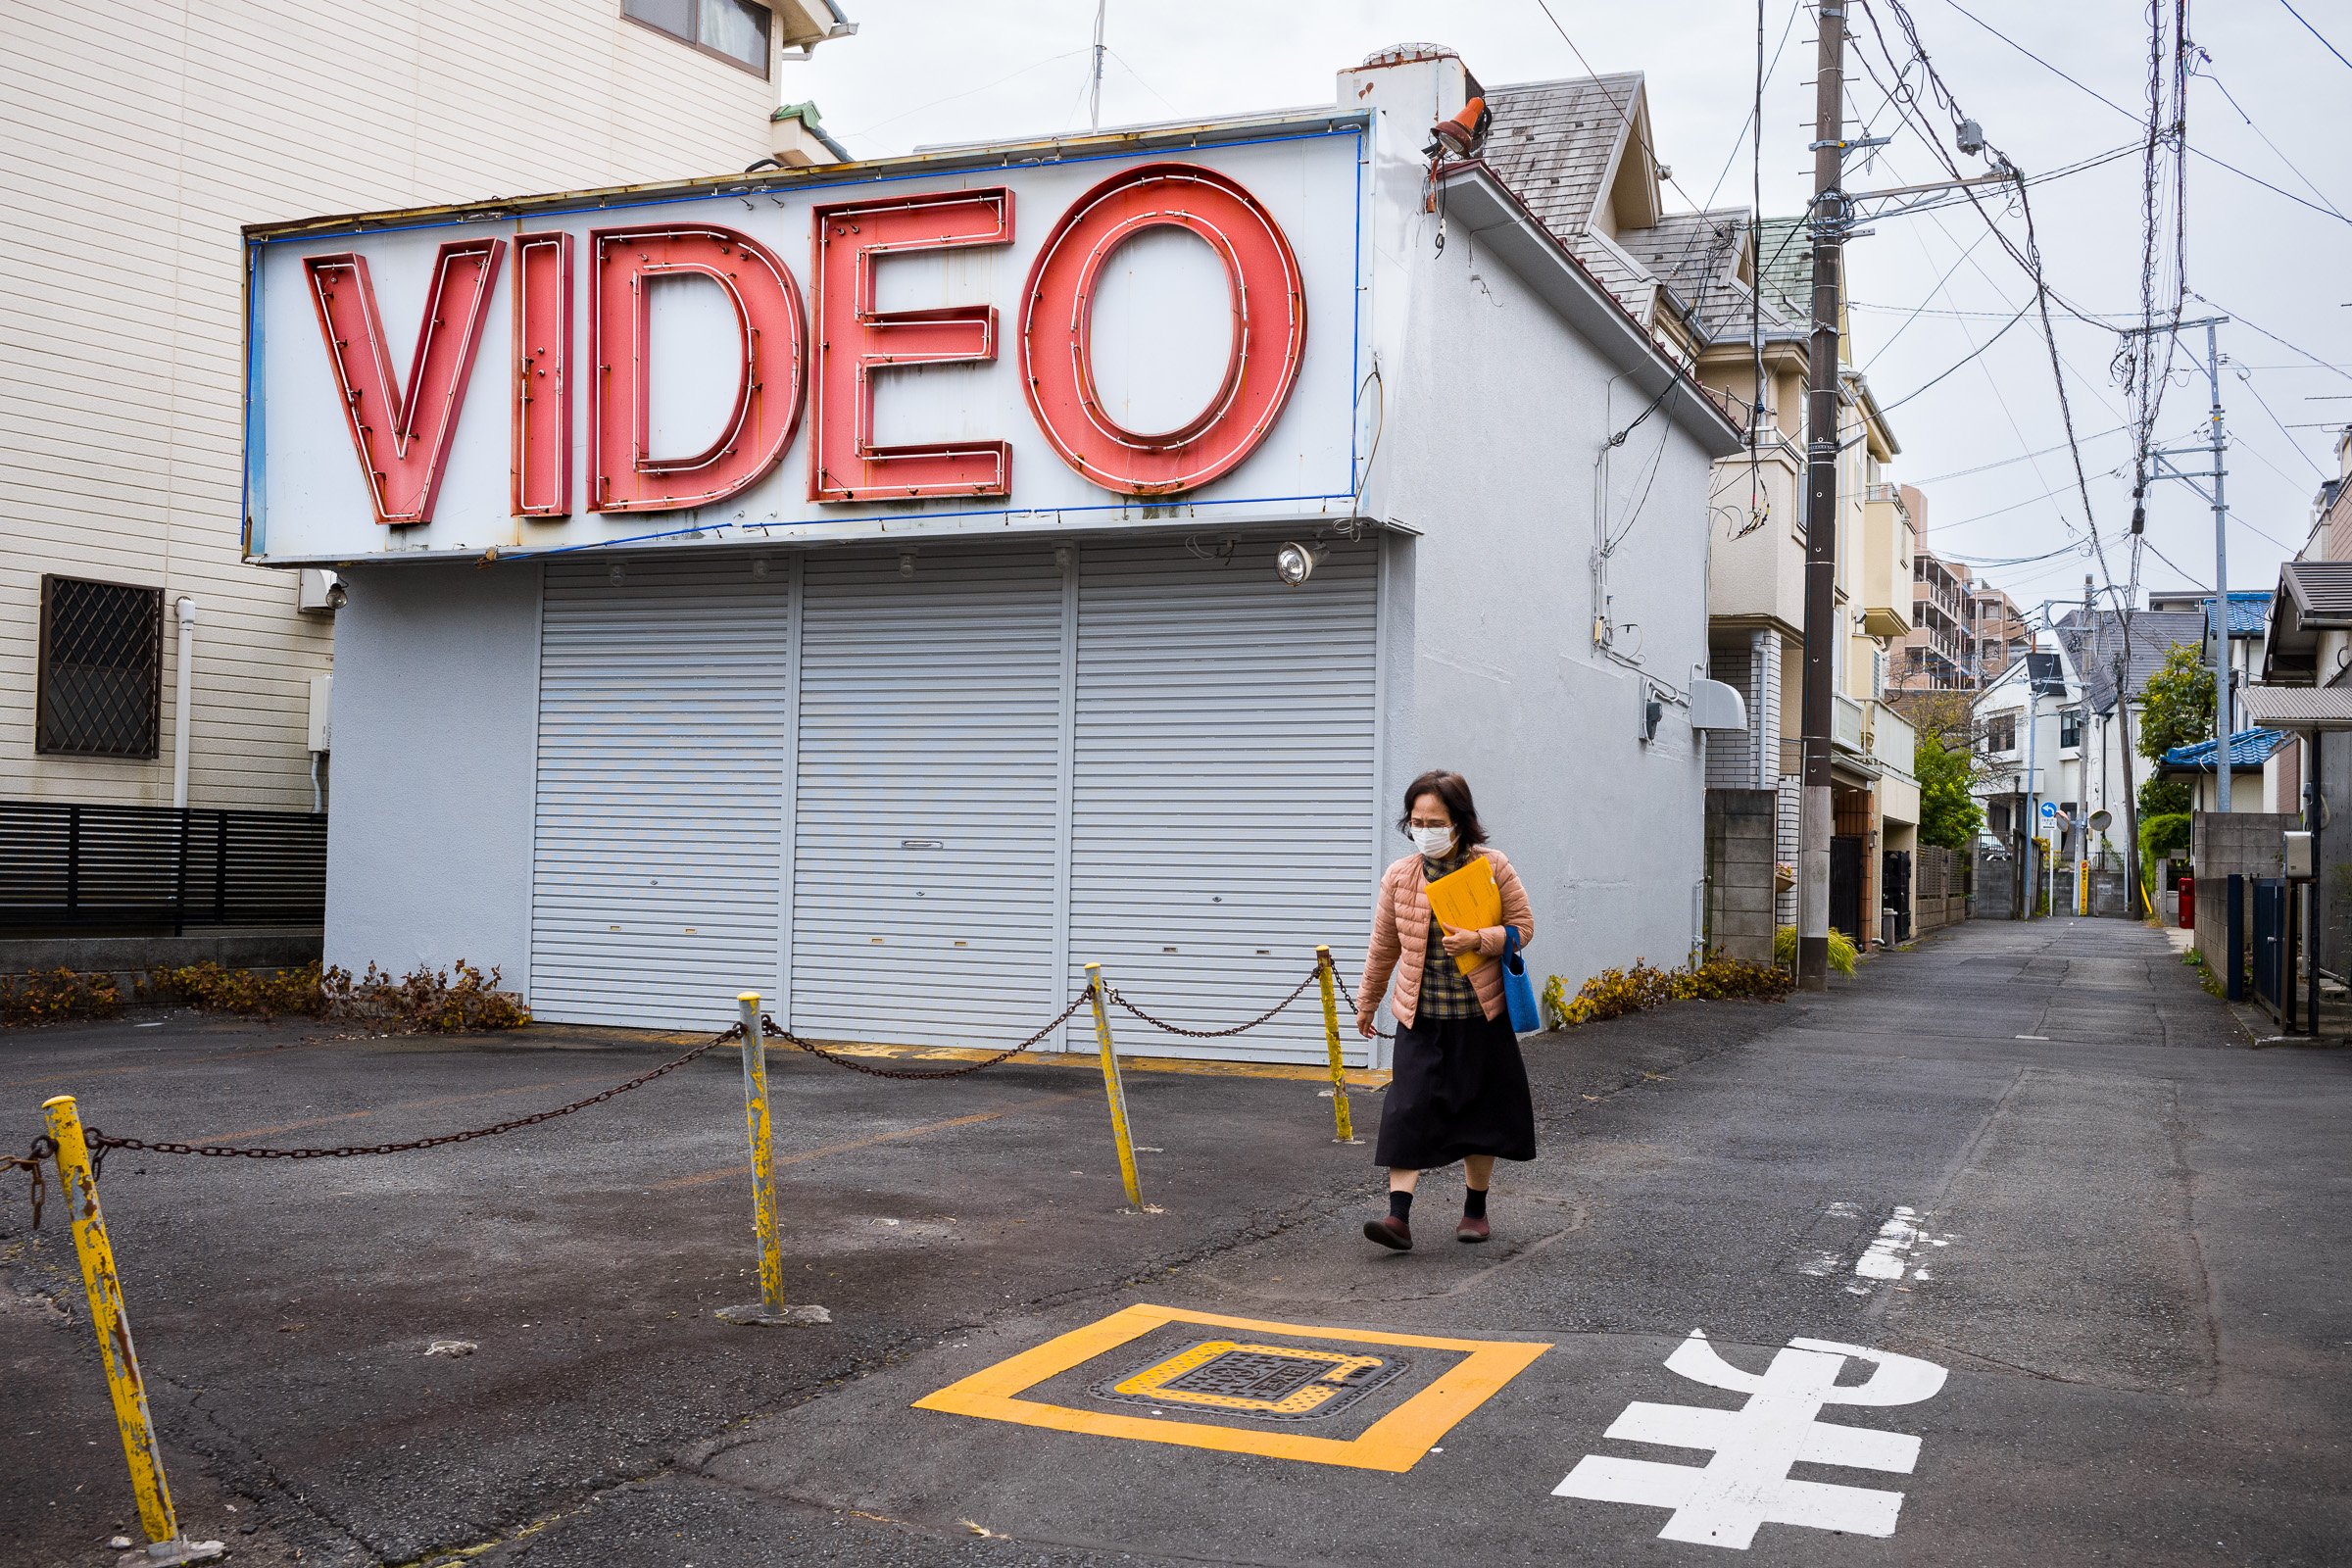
[327,564,539,992]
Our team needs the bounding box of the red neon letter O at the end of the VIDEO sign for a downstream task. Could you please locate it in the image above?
[1021,165,1307,496]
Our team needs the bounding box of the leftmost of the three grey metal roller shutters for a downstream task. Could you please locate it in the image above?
[531,555,793,1027]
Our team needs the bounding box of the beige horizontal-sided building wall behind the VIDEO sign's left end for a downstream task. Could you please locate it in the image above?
[0,0,807,808]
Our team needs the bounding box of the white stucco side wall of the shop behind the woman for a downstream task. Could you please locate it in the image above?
[1374,230,1712,990]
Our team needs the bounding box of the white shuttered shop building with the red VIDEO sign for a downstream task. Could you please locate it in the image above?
[247,47,1742,1081]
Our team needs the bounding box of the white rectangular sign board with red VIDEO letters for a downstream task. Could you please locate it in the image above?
[247,122,1369,564]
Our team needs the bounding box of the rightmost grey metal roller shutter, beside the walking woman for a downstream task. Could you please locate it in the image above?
[1070,541,1378,1062]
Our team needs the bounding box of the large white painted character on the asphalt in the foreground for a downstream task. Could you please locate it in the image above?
[1552,1328,1945,1551]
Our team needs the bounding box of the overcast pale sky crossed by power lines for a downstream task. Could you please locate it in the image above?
[783,0,2352,625]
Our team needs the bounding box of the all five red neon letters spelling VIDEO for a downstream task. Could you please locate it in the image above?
[304,165,1307,526]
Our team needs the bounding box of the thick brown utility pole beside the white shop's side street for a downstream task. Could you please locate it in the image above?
[1796,0,1858,990]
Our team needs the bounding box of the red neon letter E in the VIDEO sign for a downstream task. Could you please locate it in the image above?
[809,190,1013,501]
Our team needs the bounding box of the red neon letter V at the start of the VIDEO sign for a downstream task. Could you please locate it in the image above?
[304,237,506,526]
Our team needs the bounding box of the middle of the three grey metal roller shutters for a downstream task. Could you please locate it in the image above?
[793,546,1068,1046]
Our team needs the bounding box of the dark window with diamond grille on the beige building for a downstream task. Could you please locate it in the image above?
[33,576,163,757]
